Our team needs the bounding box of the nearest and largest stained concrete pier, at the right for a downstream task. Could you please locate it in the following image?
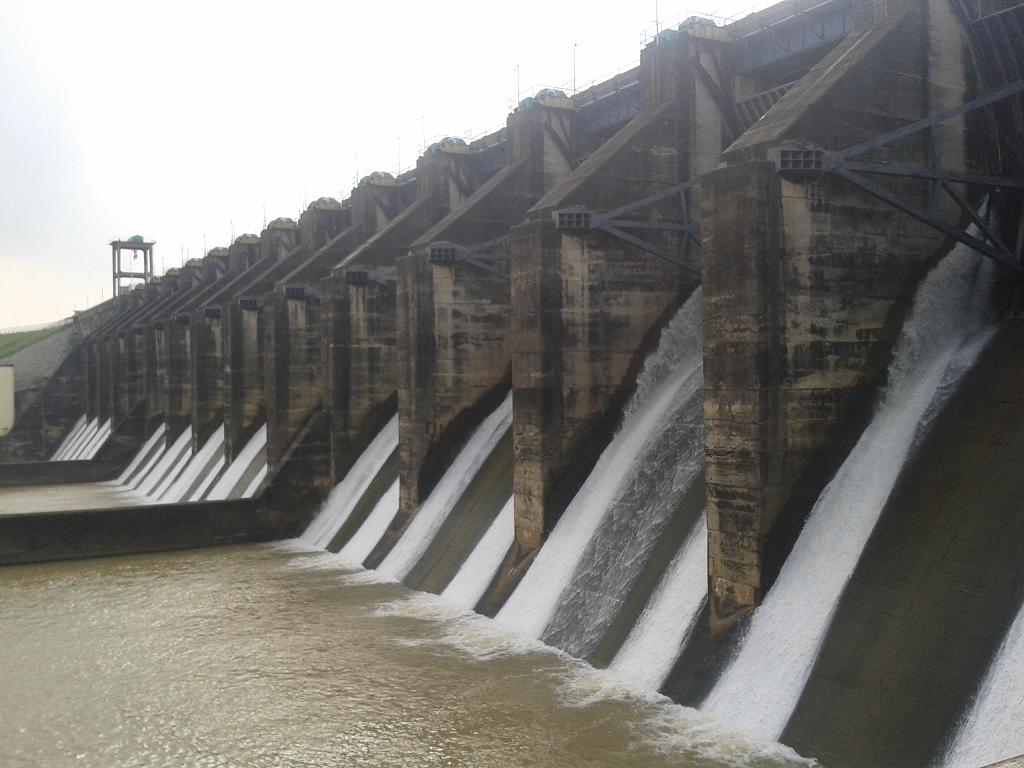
[700,2,971,629]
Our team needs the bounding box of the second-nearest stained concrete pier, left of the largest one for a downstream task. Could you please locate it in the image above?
[511,28,722,559]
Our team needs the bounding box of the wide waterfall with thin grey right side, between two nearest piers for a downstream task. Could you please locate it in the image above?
[497,289,703,652]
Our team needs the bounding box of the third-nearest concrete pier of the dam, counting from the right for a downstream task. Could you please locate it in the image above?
[398,93,575,536]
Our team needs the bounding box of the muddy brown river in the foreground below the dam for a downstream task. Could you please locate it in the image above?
[0,544,808,768]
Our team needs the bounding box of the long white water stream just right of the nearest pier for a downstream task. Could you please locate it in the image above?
[703,247,991,738]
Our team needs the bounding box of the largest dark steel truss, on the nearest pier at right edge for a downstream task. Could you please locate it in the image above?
[776,80,1024,271]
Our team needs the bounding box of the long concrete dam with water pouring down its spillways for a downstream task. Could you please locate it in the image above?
[0,0,1024,768]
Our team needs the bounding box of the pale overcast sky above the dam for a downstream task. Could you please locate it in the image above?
[0,0,771,328]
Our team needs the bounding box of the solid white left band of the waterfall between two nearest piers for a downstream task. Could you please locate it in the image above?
[497,290,701,639]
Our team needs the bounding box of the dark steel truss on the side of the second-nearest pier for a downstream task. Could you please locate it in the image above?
[551,179,700,275]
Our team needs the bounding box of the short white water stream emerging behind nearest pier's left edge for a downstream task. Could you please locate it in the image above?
[608,515,708,690]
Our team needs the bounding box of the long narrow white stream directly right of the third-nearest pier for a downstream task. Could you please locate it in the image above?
[377,392,512,582]
